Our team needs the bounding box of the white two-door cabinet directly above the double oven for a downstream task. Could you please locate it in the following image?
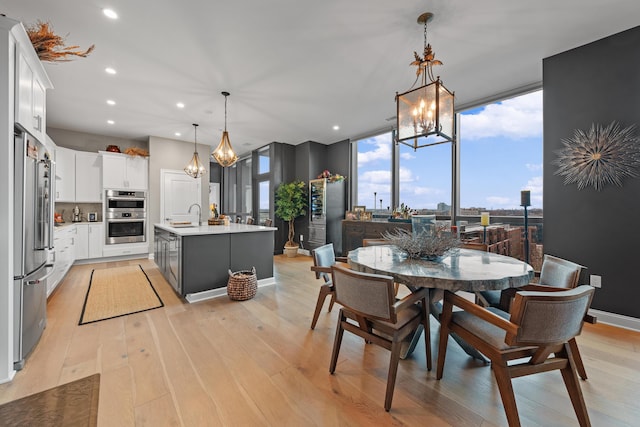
[100,151,149,191]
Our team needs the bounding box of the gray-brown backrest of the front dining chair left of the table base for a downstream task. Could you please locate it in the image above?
[331,265,397,327]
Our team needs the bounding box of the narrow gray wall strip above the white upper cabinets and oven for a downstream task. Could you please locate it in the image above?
[47,127,149,153]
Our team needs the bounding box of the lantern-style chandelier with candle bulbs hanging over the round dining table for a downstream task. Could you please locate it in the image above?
[396,12,455,151]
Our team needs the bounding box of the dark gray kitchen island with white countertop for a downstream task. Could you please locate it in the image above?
[154,223,277,302]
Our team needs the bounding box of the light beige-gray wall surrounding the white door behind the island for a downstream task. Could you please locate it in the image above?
[147,136,211,253]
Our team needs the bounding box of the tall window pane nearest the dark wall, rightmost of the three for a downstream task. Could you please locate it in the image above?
[458,90,542,217]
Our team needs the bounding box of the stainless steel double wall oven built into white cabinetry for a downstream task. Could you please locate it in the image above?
[105,190,147,245]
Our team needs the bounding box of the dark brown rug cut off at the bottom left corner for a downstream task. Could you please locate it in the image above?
[0,374,100,427]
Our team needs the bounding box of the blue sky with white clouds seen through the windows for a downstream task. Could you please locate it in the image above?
[358,90,543,209]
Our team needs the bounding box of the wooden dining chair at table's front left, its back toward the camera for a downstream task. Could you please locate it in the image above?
[329,265,428,411]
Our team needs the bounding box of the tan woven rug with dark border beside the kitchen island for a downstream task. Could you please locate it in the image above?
[79,265,164,325]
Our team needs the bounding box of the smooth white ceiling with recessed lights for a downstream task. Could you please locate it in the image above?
[0,0,640,154]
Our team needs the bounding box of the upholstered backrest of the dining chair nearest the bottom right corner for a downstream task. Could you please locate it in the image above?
[505,285,594,346]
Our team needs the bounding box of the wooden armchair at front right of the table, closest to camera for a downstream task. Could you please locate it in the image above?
[436,285,594,427]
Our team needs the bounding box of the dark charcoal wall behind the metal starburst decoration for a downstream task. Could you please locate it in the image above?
[543,23,640,318]
